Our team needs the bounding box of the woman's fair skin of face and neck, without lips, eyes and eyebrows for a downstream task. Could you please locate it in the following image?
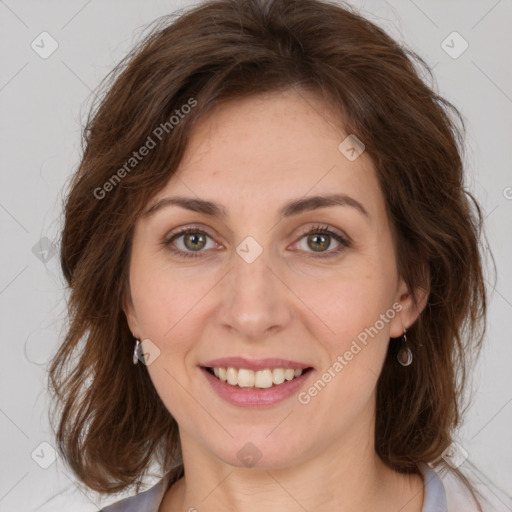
[124,90,427,512]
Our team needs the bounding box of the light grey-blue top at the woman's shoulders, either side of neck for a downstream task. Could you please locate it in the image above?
[102,464,448,512]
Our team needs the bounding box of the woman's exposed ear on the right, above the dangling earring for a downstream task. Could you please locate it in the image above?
[389,268,430,338]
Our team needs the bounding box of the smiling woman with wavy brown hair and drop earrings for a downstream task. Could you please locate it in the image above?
[50,0,500,512]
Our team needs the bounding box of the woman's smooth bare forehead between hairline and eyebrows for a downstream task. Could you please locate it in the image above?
[155,90,384,220]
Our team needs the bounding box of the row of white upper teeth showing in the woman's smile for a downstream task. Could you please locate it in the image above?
[213,367,302,389]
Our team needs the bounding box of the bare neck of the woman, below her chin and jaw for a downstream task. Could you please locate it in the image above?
[159,422,424,512]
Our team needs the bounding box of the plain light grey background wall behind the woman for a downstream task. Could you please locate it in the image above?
[0,0,512,511]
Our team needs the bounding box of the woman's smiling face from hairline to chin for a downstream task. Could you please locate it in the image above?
[124,91,424,467]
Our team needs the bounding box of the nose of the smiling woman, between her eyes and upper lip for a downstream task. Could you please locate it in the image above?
[218,247,293,341]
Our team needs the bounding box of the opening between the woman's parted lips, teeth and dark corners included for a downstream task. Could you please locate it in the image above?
[201,366,313,389]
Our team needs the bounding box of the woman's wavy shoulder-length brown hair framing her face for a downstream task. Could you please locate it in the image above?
[50,0,486,504]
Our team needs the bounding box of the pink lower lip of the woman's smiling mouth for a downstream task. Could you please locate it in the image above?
[201,368,313,407]
